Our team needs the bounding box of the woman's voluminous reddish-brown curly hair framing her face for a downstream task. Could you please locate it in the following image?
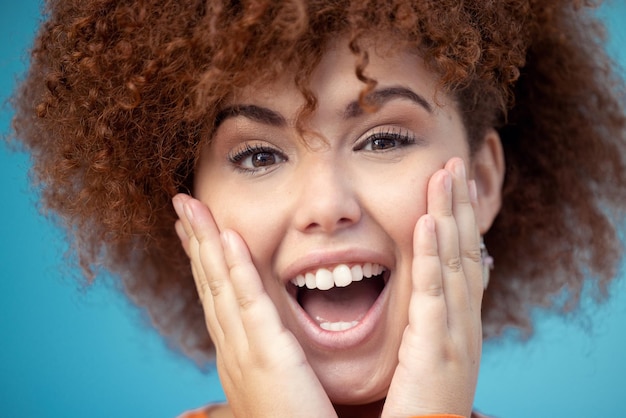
[13,0,626,358]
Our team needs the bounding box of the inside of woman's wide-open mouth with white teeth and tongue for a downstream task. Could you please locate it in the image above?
[291,263,389,331]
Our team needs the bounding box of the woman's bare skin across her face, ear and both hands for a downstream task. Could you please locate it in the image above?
[173,38,504,417]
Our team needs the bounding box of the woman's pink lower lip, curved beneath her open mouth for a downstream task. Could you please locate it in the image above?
[290,283,389,350]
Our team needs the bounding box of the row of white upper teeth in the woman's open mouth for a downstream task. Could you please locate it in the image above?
[291,263,384,290]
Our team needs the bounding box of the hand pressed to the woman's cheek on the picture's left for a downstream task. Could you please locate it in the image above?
[173,195,336,418]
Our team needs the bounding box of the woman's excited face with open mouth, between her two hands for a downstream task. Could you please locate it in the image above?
[195,39,480,404]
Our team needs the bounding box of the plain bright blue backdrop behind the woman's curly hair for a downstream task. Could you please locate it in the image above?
[0,0,626,418]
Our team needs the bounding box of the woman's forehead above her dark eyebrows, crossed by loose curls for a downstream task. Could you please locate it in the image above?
[224,39,447,113]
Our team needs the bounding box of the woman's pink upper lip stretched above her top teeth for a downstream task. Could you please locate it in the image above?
[280,248,392,284]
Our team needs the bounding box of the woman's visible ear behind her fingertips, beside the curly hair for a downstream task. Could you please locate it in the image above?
[470,129,505,234]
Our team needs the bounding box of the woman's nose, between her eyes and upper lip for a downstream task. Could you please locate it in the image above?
[293,159,362,234]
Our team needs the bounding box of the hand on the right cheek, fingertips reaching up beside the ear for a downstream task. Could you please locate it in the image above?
[382,158,483,418]
